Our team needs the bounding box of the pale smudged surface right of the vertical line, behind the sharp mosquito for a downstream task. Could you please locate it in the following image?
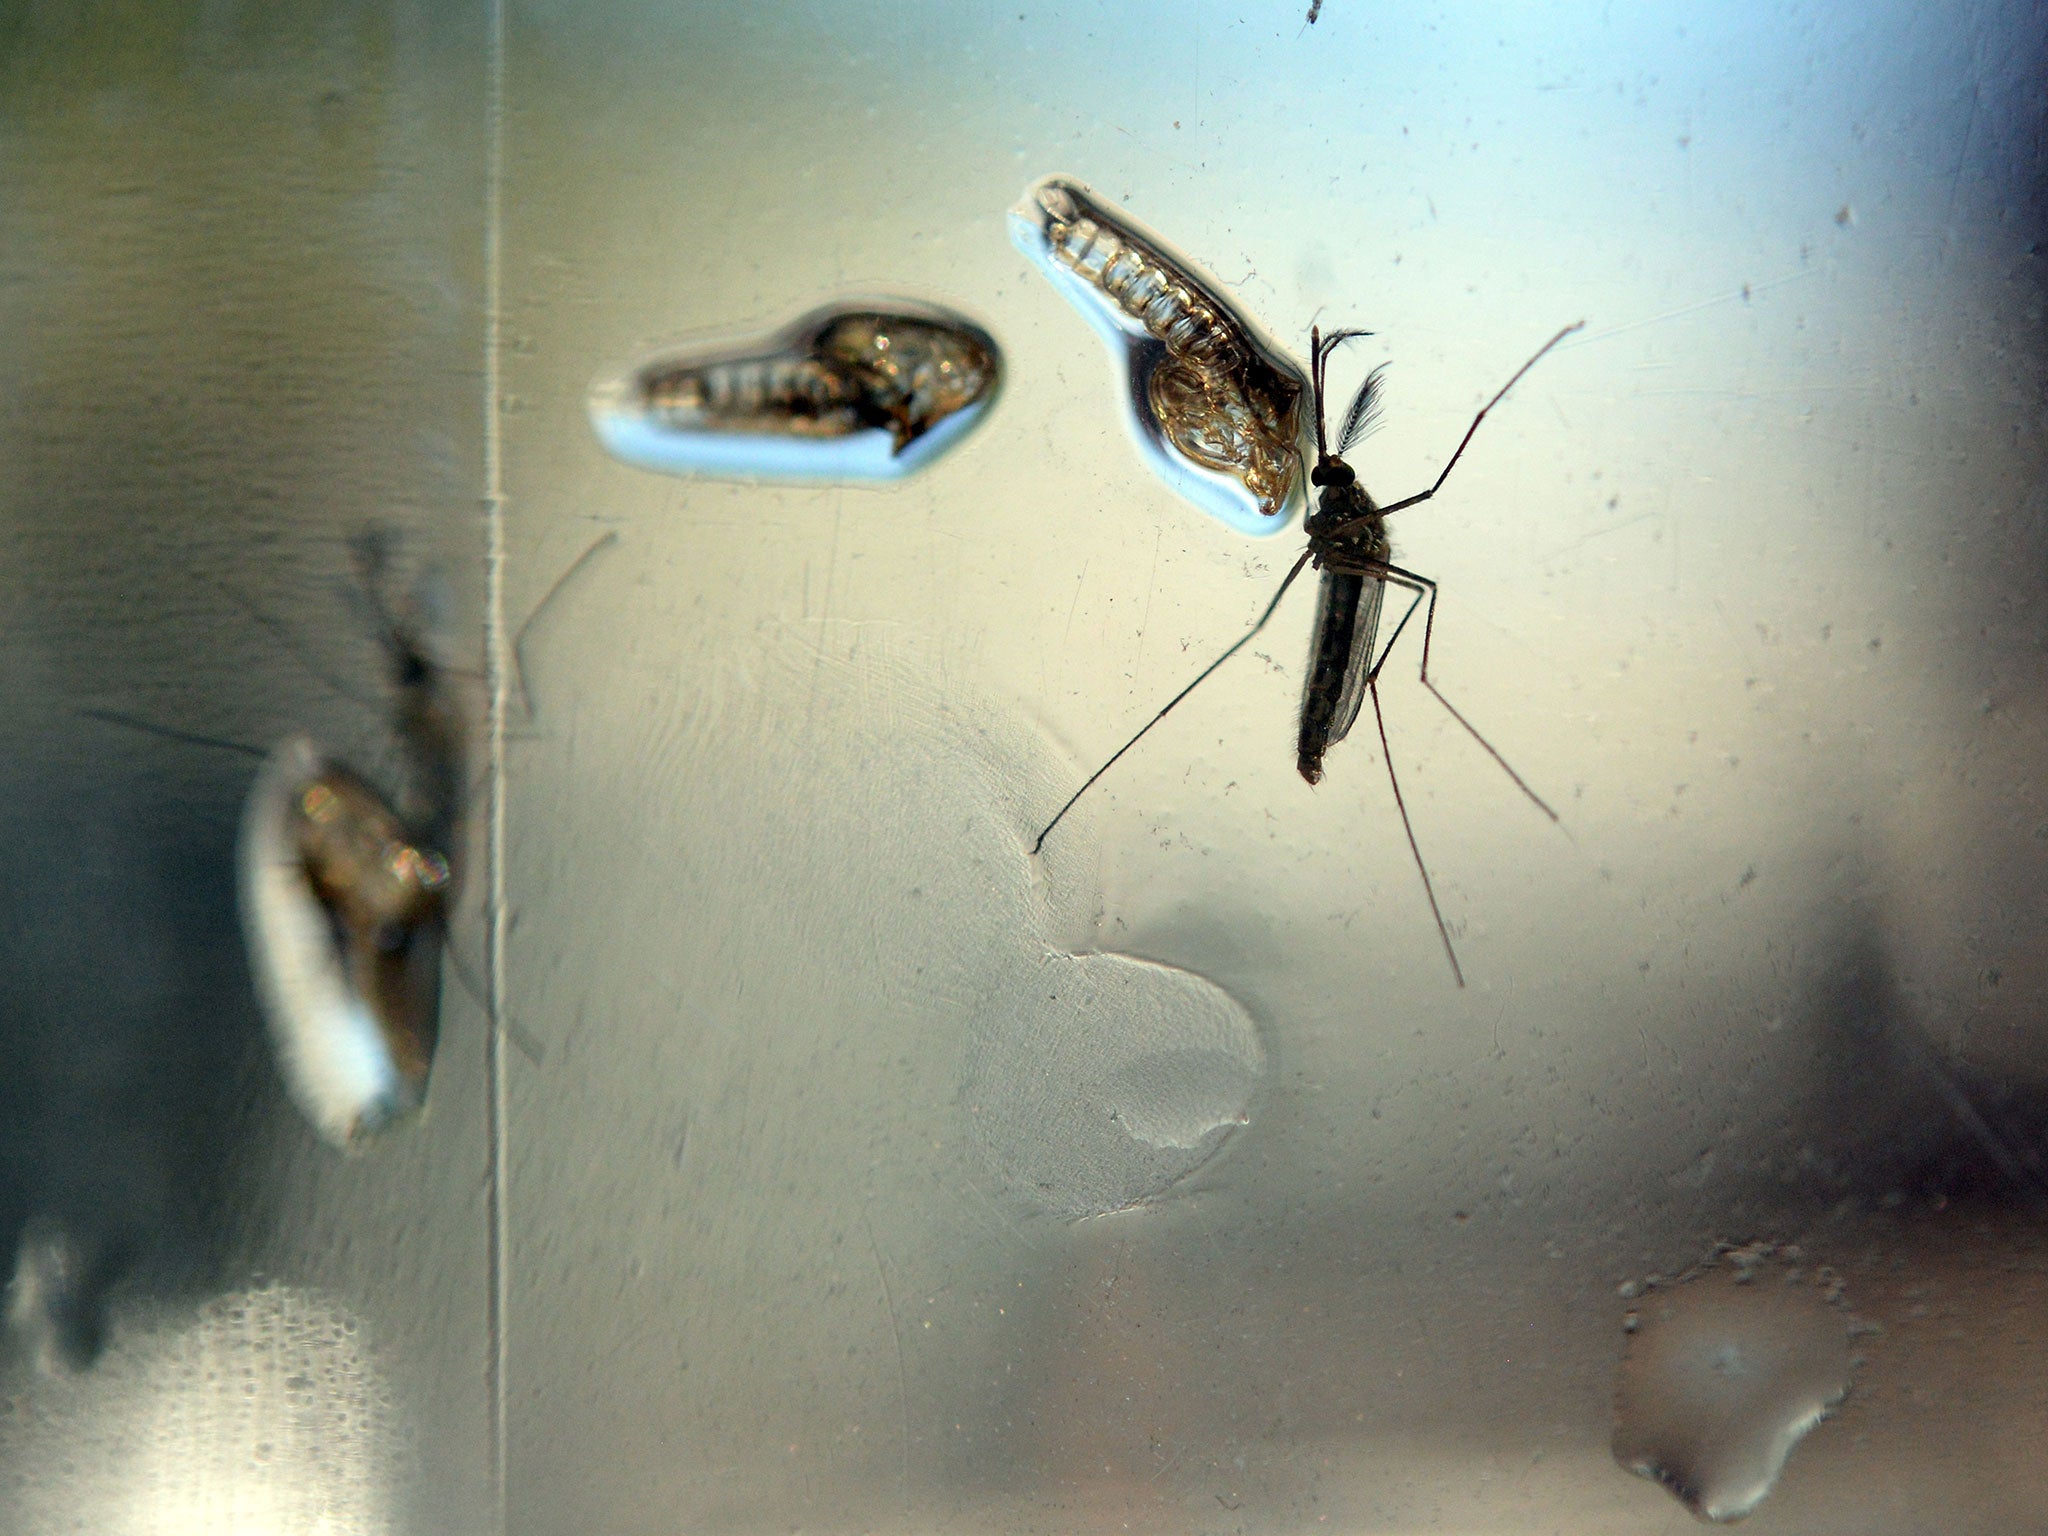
[506,0,2048,1532]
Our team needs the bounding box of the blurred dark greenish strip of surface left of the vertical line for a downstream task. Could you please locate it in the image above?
[0,4,487,1534]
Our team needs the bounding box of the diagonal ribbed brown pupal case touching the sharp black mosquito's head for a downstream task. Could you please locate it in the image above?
[1010,176,1309,532]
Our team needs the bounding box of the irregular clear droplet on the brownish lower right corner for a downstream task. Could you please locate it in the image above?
[1614,1247,1849,1520]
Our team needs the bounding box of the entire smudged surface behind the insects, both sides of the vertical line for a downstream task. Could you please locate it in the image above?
[0,0,2048,1532]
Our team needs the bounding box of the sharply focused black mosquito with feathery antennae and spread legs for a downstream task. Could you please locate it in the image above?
[1032,319,1585,987]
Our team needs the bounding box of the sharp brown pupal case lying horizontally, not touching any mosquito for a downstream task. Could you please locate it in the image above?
[590,299,1001,479]
